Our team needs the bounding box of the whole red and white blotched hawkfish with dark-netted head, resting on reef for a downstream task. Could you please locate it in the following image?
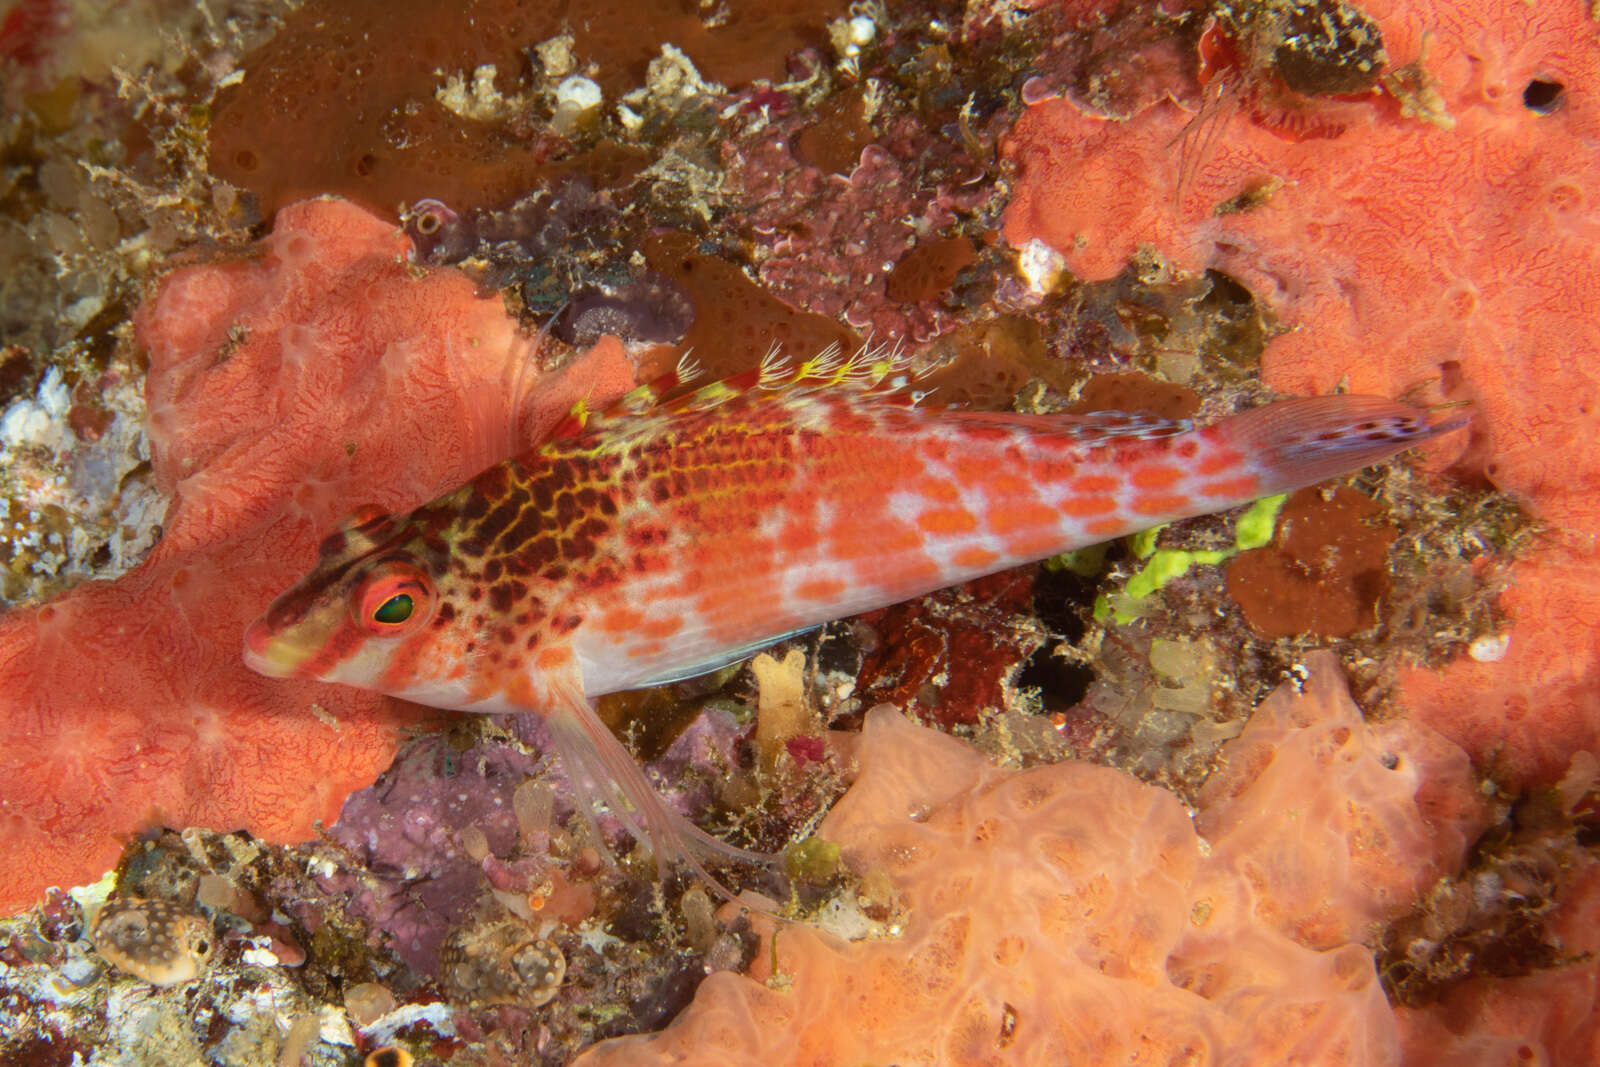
[245,355,1464,895]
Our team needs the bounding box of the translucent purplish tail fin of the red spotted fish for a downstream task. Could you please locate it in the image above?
[1216,395,1472,496]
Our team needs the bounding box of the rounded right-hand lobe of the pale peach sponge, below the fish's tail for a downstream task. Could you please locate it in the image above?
[1195,653,1488,949]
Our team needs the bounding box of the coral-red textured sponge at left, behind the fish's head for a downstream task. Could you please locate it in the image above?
[0,200,632,912]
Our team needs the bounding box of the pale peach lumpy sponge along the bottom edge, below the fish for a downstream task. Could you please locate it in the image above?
[578,657,1466,1067]
